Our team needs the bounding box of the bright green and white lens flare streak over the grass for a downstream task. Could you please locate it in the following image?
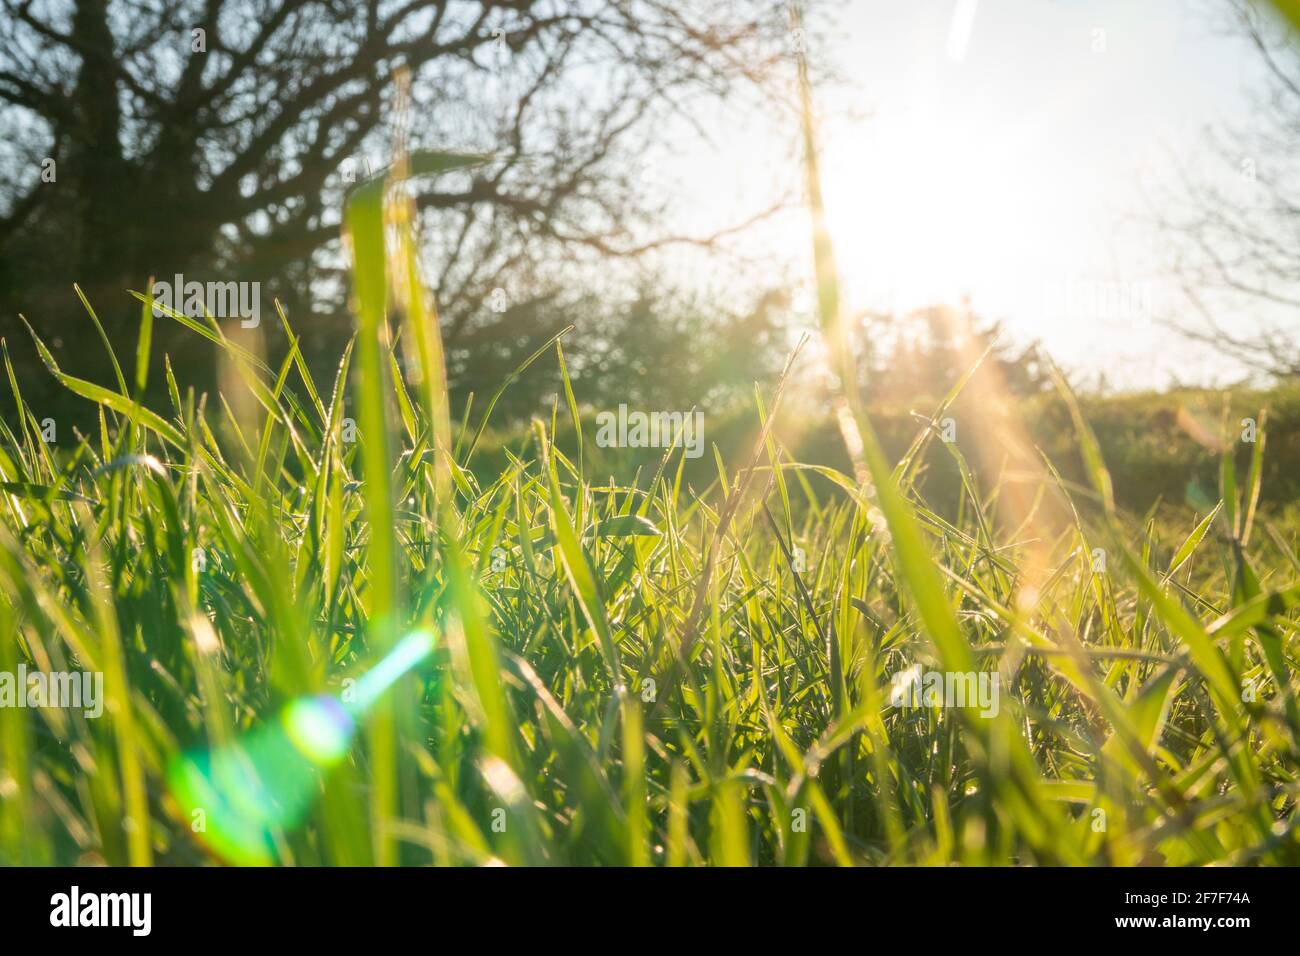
[166,631,434,866]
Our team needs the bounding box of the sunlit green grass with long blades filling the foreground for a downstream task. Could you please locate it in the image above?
[0,141,1300,865]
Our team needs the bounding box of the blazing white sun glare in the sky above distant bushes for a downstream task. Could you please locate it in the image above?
[823,67,1092,329]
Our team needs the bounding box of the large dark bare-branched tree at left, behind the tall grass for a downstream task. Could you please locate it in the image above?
[0,0,787,408]
